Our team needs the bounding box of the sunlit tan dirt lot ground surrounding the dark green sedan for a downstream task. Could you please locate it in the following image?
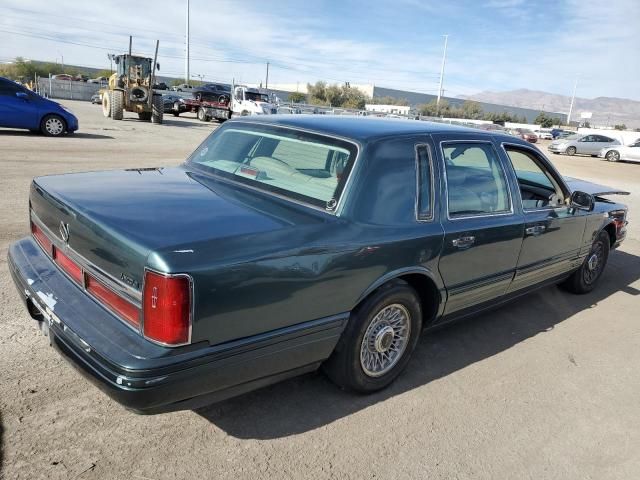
[0,102,640,480]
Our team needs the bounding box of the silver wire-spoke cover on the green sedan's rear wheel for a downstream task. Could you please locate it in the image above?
[360,303,411,377]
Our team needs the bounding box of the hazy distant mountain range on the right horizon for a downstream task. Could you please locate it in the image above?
[459,89,640,128]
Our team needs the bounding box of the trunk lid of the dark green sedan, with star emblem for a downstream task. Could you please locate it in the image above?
[30,168,318,291]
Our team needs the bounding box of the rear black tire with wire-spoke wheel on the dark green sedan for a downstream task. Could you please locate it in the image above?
[322,280,422,393]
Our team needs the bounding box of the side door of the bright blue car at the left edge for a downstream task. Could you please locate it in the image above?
[0,79,38,128]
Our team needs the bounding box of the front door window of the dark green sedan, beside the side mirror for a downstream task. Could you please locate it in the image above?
[505,146,564,210]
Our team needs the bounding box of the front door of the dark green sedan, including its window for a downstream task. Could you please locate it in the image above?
[503,143,587,293]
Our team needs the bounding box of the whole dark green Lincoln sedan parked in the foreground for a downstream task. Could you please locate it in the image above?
[9,115,627,413]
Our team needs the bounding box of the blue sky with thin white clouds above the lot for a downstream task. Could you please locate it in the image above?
[0,0,640,100]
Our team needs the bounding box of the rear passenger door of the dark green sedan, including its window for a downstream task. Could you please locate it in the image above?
[439,135,523,318]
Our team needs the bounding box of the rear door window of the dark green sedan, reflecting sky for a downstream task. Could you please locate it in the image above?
[442,142,511,218]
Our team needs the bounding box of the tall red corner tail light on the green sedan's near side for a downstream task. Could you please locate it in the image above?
[142,271,191,345]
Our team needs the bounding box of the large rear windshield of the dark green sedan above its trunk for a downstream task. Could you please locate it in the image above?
[187,122,357,210]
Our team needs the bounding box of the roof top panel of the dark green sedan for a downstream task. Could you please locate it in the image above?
[231,115,504,141]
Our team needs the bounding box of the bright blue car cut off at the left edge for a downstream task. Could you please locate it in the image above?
[0,77,78,137]
